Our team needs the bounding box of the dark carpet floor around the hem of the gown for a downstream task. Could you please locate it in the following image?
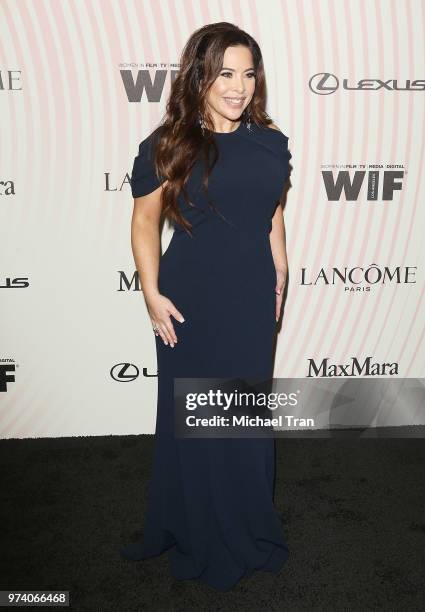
[0,435,425,612]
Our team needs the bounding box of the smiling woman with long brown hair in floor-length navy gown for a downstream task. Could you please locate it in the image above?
[121,23,291,591]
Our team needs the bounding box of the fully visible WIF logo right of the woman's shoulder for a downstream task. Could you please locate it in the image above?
[322,165,404,202]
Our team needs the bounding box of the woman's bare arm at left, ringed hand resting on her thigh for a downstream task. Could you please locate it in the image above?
[131,185,184,347]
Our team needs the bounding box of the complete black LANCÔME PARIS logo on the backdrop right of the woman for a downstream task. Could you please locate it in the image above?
[300,263,417,291]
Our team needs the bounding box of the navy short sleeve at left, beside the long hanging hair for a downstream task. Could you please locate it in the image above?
[130,130,165,198]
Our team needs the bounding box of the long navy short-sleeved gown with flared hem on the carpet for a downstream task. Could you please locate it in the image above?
[121,117,291,591]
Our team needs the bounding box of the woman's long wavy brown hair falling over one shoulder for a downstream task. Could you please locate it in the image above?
[151,22,272,235]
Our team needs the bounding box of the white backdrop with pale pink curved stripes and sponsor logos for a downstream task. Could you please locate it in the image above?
[0,0,425,438]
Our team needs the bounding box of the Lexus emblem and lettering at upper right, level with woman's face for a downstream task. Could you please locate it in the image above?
[308,72,425,96]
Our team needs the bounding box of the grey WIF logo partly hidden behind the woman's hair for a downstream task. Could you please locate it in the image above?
[118,62,180,102]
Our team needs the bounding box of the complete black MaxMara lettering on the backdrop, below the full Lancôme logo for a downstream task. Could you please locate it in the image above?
[307,356,398,378]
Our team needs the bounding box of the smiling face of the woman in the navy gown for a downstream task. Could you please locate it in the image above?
[206,45,255,127]
